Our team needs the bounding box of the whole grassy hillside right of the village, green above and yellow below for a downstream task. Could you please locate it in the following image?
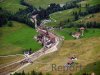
[14,0,100,75]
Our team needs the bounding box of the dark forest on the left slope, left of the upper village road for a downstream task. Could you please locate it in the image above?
[0,0,35,28]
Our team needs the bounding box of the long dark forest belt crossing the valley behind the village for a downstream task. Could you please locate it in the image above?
[0,0,83,28]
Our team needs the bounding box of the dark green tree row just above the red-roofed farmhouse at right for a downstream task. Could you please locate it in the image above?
[58,20,100,28]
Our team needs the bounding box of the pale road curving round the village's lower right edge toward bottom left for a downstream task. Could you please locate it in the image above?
[8,34,62,75]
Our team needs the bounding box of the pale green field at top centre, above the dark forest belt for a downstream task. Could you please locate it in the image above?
[25,0,70,8]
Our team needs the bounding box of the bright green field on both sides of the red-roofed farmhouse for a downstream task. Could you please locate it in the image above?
[56,28,100,40]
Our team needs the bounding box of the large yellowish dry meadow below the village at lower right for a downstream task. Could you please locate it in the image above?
[19,37,100,75]
